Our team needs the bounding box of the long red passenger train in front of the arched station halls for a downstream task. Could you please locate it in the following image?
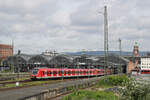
[30,68,111,80]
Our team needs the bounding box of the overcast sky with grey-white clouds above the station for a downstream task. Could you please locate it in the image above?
[0,0,150,54]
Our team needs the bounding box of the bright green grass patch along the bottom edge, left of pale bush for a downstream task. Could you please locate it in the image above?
[62,90,119,100]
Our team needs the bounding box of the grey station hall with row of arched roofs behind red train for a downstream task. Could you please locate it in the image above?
[3,54,128,72]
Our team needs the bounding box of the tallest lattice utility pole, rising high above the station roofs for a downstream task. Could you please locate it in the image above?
[104,6,108,79]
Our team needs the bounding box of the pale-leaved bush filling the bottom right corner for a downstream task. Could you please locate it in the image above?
[120,79,150,100]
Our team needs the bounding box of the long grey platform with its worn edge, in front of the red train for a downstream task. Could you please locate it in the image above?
[0,77,101,100]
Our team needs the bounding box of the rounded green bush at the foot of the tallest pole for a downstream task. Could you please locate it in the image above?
[97,75,129,87]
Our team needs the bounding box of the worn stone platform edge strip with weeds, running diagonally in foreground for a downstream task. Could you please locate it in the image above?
[20,78,99,100]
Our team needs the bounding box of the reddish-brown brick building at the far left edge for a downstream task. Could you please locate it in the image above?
[0,44,13,59]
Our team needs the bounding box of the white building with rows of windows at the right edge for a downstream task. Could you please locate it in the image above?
[141,57,150,70]
